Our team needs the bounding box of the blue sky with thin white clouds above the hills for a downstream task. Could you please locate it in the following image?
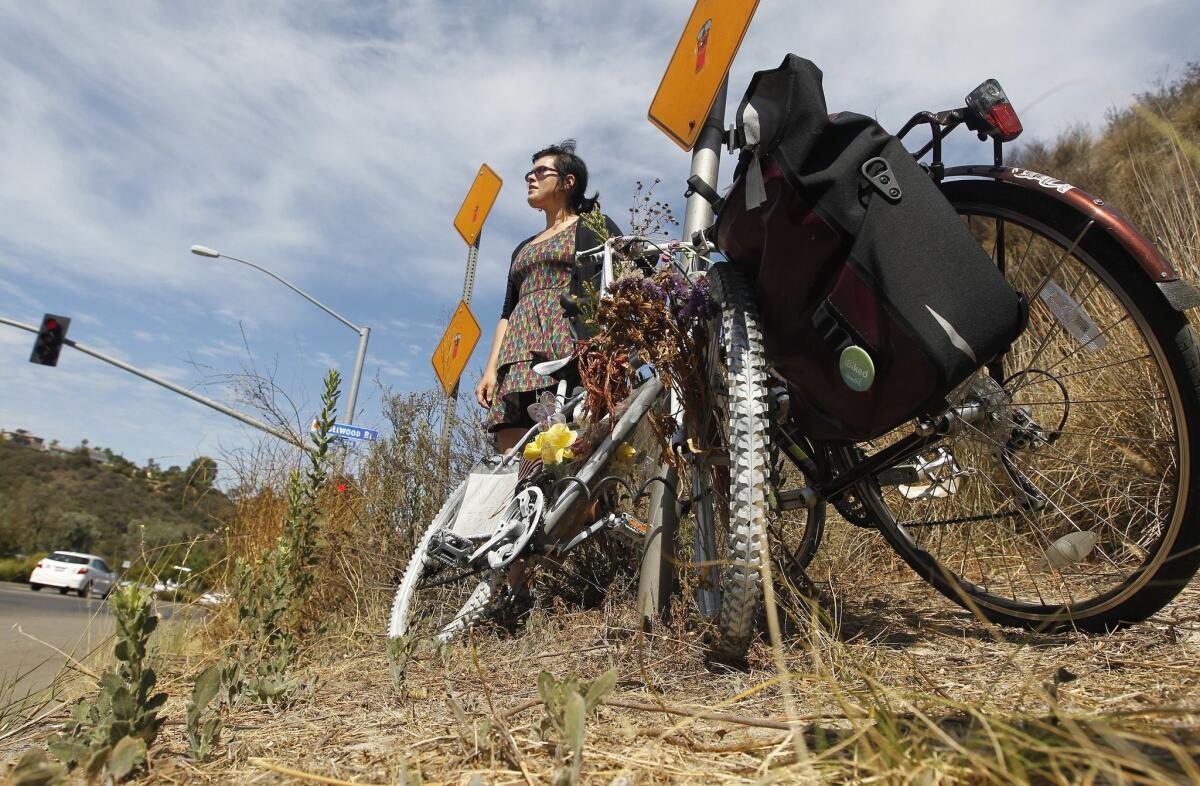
[0,0,1200,477]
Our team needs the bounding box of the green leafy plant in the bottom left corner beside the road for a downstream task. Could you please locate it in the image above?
[49,584,167,781]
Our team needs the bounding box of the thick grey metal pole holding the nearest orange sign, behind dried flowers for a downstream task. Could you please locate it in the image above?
[637,77,730,626]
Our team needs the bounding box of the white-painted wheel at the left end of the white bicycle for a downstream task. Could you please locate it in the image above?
[388,480,504,643]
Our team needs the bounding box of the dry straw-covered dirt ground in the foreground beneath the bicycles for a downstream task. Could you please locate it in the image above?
[0,534,1200,785]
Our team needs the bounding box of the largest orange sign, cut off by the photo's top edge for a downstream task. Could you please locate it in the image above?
[647,0,758,150]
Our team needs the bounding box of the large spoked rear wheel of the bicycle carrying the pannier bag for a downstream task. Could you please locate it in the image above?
[860,180,1200,632]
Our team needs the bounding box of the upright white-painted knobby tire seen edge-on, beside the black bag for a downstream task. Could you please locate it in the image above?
[697,264,770,661]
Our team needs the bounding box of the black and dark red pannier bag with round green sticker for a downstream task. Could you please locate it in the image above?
[716,55,1027,442]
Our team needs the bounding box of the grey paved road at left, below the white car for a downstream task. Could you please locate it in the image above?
[0,582,184,704]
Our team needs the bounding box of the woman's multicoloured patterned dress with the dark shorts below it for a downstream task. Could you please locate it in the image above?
[487,223,575,430]
